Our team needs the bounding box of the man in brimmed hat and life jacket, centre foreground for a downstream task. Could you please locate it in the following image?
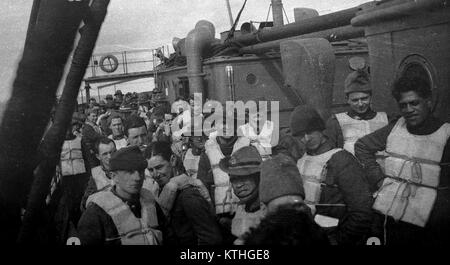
[219,146,266,245]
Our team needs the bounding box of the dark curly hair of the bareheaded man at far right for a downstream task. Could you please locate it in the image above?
[392,76,431,101]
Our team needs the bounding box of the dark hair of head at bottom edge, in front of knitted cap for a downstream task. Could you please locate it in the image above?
[243,205,330,246]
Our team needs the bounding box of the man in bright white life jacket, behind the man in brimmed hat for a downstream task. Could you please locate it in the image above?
[238,103,278,160]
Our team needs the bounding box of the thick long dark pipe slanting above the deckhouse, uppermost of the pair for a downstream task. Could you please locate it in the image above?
[227,7,360,46]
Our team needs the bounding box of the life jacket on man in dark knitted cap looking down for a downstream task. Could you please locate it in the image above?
[297,148,343,227]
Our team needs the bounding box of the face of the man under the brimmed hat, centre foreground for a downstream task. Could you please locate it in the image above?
[230,175,258,204]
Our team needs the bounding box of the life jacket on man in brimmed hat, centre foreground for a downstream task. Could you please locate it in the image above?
[231,204,266,237]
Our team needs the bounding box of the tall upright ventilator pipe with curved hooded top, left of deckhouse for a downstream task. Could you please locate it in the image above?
[186,20,215,96]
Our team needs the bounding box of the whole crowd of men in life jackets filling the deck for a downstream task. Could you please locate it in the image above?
[53,70,450,245]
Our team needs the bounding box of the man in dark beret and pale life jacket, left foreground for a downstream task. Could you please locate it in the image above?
[78,146,163,245]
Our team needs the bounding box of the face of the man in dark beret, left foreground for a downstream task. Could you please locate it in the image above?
[113,170,145,196]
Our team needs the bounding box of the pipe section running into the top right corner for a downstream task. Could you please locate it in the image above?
[351,0,450,27]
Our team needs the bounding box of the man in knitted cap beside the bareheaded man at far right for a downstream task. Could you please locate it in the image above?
[326,70,388,155]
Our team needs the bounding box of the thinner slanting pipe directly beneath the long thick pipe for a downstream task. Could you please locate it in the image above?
[239,26,364,54]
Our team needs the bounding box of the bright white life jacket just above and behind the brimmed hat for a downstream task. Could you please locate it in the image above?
[239,121,277,160]
